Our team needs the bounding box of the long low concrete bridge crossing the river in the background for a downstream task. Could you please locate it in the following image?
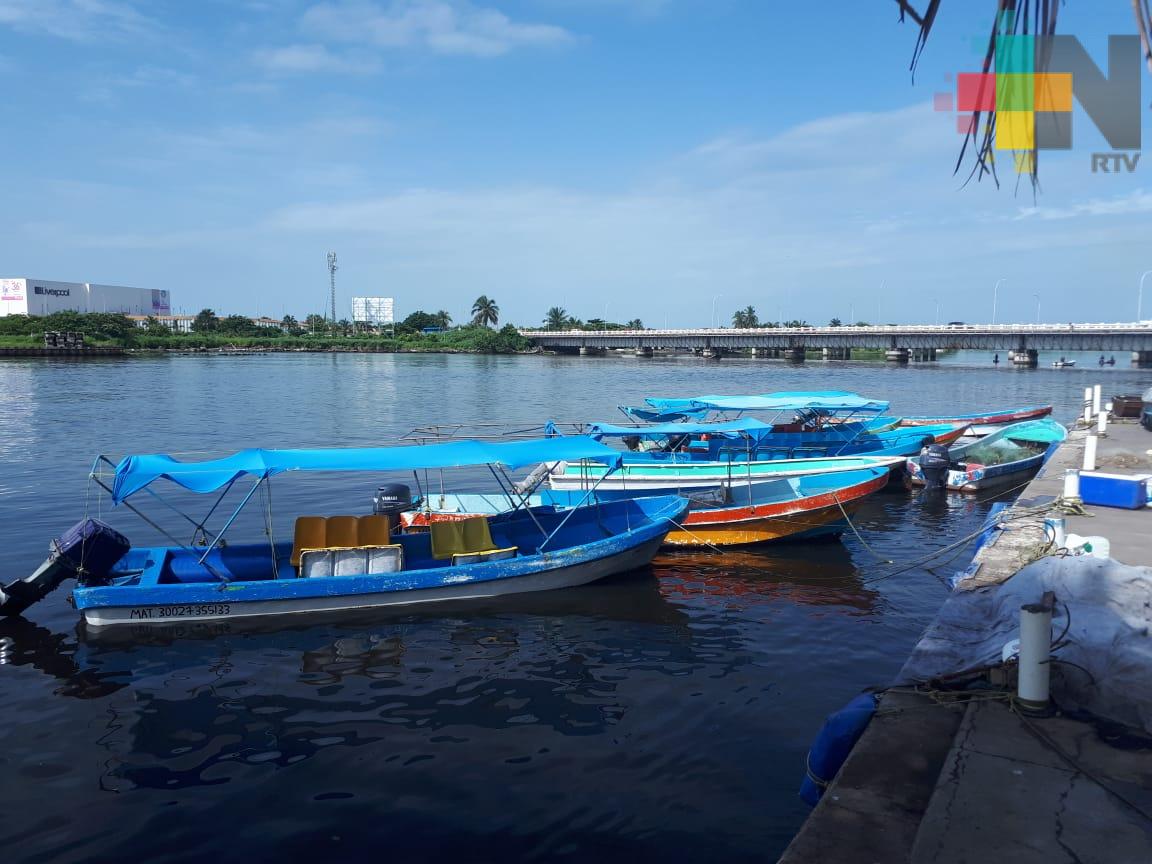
[521,321,1152,366]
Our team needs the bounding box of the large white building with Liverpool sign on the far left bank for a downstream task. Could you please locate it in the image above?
[0,278,172,316]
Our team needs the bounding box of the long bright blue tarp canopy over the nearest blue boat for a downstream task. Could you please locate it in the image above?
[112,435,620,503]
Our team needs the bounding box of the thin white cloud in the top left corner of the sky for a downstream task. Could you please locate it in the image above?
[0,0,154,41]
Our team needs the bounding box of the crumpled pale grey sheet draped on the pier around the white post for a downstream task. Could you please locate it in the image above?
[900,555,1152,733]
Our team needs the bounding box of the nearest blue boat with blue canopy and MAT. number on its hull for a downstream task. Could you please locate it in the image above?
[0,437,689,627]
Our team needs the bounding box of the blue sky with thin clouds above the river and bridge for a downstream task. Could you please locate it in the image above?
[0,0,1152,327]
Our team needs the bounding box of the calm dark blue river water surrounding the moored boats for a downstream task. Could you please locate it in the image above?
[0,355,1152,864]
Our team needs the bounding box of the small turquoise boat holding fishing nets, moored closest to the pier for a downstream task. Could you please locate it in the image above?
[907,418,1068,492]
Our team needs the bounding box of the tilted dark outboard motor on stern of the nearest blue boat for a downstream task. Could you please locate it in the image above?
[0,520,131,616]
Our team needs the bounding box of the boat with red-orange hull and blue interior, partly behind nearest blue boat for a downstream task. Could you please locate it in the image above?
[403,467,889,546]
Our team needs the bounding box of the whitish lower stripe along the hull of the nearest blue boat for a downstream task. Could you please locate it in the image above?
[84,536,664,627]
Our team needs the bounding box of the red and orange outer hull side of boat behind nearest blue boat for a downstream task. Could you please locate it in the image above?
[665,475,888,546]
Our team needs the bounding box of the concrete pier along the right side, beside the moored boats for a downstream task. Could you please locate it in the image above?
[780,420,1152,864]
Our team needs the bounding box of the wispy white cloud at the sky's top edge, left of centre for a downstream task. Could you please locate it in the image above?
[301,0,571,58]
